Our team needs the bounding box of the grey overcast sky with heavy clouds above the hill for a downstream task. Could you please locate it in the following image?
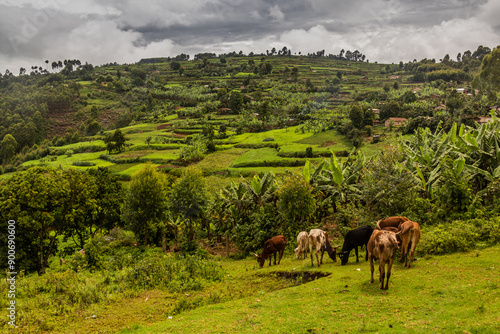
[0,0,500,75]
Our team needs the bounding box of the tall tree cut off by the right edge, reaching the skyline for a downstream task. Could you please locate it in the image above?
[472,45,500,101]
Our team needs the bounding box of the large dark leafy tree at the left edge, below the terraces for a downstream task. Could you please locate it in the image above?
[0,167,71,275]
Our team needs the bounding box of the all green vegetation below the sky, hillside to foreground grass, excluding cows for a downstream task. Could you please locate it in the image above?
[0,46,500,333]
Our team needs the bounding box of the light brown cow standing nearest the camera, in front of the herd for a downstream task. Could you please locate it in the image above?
[367,230,398,290]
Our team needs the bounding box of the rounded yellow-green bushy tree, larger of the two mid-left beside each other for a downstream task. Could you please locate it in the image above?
[122,163,169,246]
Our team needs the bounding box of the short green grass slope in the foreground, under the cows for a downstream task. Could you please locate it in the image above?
[2,246,500,334]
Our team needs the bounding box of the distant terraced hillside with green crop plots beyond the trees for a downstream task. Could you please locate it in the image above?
[4,56,454,187]
